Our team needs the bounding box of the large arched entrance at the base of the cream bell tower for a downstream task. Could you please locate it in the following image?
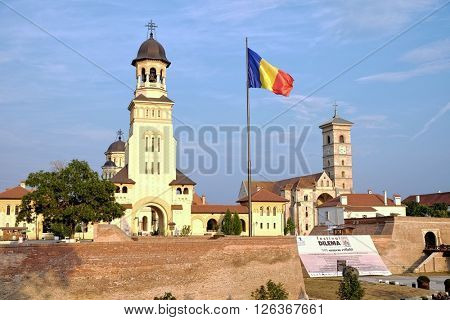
[136,205,167,236]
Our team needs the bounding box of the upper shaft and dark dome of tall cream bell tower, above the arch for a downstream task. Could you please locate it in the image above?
[127,21,176,203]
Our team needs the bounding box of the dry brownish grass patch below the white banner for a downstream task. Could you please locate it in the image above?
[304,277,431,300]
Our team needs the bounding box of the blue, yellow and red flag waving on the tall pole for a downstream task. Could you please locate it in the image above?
[247,49,294,96]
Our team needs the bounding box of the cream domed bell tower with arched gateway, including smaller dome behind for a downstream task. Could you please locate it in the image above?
[102,33,199,235]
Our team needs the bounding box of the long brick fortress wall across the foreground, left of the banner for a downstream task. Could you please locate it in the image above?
[0,237,305,299]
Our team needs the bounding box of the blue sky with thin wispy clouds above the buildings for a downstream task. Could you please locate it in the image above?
[0,0,450,203]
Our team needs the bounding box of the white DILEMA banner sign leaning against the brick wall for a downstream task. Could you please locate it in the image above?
[297,235,391,277]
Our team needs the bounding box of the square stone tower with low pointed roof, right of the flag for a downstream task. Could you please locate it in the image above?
[319,104,353,194]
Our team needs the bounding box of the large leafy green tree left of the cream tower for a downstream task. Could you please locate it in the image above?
[17,160,124,236]
